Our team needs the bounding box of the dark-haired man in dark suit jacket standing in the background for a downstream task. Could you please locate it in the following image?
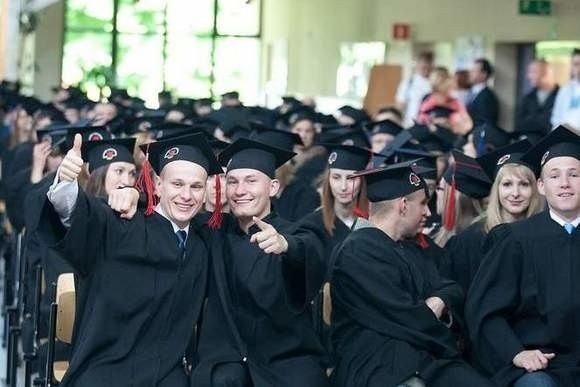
[467,58,499,126]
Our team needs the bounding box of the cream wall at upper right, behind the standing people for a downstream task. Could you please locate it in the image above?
[263,0,580,95]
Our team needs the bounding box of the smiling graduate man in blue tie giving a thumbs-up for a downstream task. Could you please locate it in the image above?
[39,134,221,387]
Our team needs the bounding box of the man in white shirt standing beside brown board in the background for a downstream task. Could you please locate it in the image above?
[395,52,433,126]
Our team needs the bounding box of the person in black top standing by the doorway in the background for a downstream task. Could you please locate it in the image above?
[516,59,559,141]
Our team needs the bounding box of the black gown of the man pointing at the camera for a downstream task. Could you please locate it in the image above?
[192,213,327,387]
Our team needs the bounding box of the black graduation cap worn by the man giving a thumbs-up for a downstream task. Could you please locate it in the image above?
[140,133,223,175]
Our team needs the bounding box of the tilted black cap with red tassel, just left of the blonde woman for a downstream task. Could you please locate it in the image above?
[443,150,492,199]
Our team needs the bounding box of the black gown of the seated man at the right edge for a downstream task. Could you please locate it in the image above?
[466,211,580,387]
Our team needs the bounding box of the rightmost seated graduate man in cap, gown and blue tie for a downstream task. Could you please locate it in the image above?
[466,127,580,387]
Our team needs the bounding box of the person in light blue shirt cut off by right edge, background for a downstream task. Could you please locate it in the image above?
[552,48,580,133]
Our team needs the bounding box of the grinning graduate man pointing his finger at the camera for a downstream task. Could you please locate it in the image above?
[192,139,327,387]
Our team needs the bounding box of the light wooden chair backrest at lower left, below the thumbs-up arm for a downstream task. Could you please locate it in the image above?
[56,273,76,344]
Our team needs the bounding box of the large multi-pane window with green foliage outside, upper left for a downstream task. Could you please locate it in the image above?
[62,0,261,103]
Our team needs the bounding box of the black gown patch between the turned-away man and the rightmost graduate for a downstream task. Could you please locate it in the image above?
[445,221,487,294]
